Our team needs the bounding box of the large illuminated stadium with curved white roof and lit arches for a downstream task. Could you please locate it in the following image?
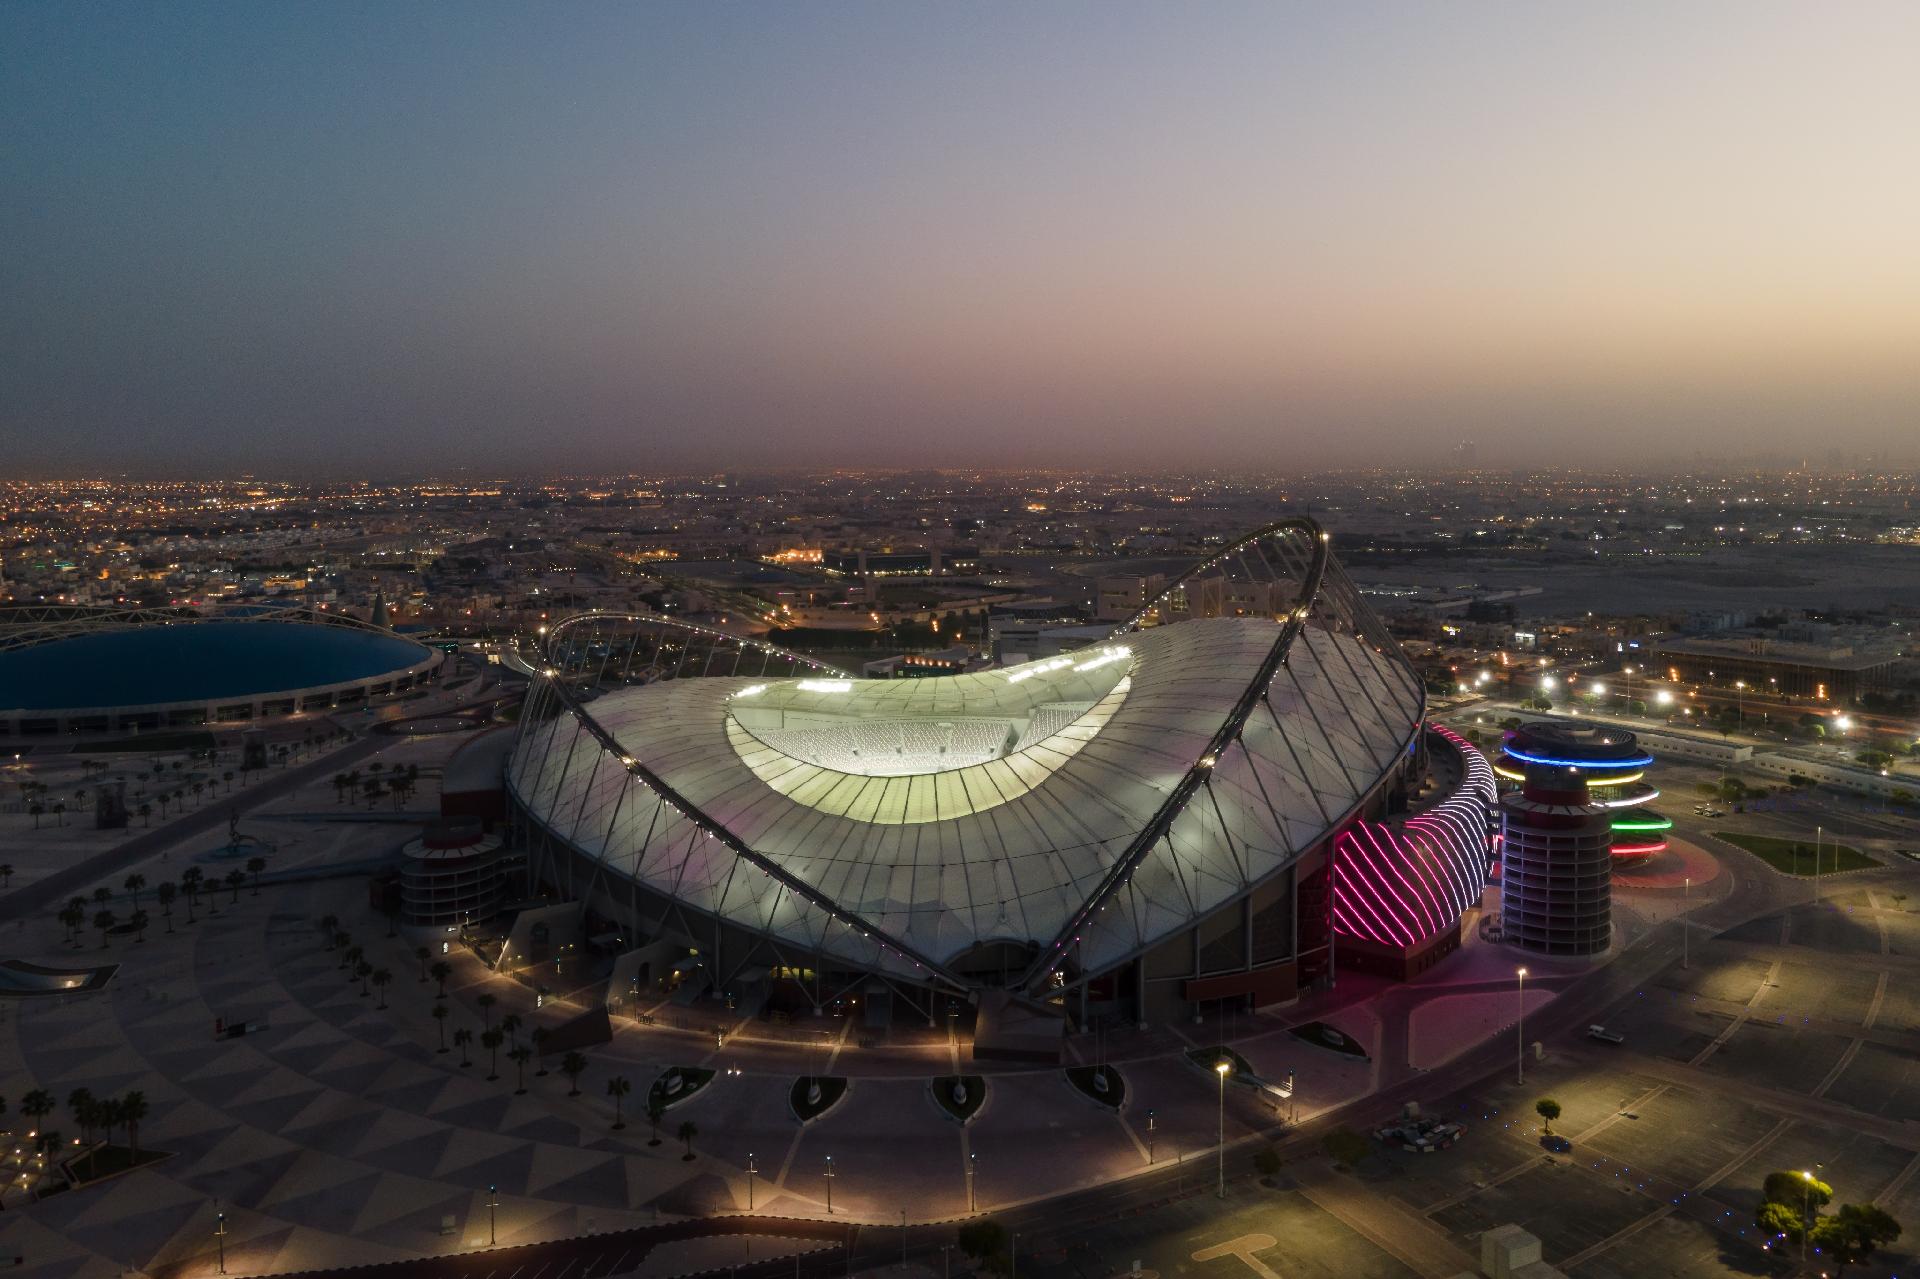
[507,520,1492,1054]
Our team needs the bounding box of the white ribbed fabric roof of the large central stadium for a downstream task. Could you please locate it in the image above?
[509,618,1421,976]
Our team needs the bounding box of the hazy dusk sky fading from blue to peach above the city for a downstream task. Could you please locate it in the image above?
[0,0,1920,474]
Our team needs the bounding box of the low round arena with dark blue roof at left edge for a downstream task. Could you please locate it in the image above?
[0,605,444,739]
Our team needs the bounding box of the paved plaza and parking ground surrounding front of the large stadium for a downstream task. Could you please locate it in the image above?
[11,702,1920,1279]
